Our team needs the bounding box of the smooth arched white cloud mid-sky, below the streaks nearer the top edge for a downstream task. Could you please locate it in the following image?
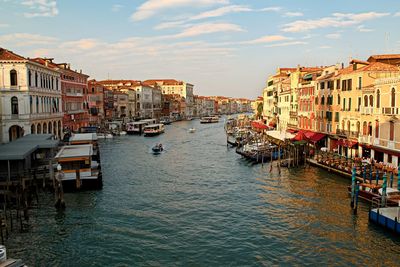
[174,23,244,38]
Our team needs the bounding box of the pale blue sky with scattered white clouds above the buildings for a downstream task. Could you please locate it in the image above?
[0,0,400,99]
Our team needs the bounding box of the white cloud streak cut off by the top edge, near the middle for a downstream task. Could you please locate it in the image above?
[131,0,229,21]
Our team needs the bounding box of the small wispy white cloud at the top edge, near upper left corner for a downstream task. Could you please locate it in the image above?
[21,0,58,18]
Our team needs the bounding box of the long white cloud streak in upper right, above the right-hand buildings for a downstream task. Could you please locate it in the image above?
[282,12,390,32]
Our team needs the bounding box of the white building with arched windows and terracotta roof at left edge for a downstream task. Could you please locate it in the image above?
[0,48,63,143]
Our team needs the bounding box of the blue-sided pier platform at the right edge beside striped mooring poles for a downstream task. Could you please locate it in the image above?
[368,207,400,234]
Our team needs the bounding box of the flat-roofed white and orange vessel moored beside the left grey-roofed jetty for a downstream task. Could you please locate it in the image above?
[55,144,103,191]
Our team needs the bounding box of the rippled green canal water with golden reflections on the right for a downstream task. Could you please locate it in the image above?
[6,120,400,266]
